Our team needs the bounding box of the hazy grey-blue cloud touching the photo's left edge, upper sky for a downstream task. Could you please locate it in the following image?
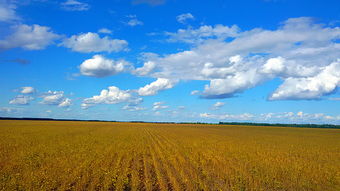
[0,24,60,50]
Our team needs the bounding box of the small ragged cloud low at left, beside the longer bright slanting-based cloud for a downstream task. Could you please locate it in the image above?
[41,90,71,107]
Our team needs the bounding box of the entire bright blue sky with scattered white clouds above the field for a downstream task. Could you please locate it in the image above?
[0,0,340,124]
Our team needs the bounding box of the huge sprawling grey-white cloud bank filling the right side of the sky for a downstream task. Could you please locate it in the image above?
[140,17,340,100]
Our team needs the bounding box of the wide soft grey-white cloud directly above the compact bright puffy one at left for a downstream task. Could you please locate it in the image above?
[61,32,128,53]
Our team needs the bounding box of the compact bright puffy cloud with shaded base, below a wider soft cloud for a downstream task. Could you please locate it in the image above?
[79,55,129,77]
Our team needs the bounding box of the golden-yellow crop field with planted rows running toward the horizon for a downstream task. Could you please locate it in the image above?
[0,120,340,191]
